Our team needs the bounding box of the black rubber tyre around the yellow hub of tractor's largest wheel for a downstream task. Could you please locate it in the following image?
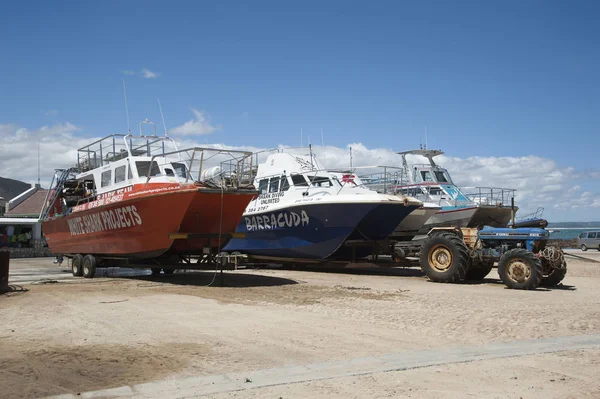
[420,232,470,283]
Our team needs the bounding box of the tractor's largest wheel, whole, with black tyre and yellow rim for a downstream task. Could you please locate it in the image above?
[420,233,470,283]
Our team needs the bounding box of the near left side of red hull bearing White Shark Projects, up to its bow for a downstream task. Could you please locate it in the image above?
[42,190,197,259]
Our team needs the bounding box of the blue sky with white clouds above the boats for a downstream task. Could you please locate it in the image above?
[0,0,600,222]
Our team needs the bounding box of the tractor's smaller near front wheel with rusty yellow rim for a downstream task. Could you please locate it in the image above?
[498,248,544,290]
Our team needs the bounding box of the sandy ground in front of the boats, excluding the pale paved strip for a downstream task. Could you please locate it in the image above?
[0,251,600,398]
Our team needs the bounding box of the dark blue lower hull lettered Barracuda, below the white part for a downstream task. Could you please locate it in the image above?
[224,202,416,260]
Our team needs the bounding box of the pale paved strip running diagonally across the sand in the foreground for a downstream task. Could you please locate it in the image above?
[53,334,600,399]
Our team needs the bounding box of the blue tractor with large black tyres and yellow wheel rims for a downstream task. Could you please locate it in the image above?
[420,226,567,290]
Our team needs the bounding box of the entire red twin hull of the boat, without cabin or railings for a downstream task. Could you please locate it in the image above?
[42,184,255,258]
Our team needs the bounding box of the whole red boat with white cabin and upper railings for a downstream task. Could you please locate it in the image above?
[42,125,256,277]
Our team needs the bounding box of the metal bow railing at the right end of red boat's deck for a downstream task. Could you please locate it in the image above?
[145,147,253,188]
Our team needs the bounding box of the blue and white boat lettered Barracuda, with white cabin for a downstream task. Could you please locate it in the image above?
[223,152,422,260]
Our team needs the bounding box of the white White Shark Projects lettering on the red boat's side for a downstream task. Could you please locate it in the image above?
[67,205,142,236]
